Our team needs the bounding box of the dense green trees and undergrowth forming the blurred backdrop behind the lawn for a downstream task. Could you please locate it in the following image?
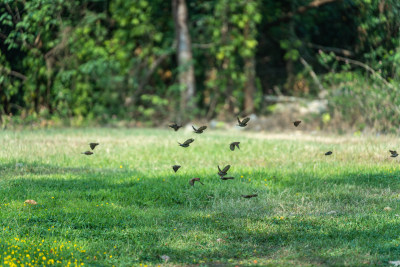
[0,0,400,131]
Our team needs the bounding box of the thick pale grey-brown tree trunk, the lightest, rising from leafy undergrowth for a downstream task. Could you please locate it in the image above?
[172,0,196,119]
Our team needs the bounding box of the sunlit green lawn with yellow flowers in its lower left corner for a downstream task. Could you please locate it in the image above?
[0,129,400,266]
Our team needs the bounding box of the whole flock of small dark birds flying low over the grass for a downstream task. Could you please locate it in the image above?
[82,117,342,198]
